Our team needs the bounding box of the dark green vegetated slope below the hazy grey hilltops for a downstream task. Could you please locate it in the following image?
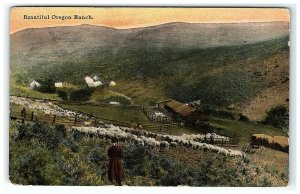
[16,37,288,107]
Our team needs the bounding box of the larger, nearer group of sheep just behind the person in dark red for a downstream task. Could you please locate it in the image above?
[71,124,245,157]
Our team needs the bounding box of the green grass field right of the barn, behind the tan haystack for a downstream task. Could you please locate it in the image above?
[209,117,287,142]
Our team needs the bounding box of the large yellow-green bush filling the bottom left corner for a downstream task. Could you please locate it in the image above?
[9,140,63,185]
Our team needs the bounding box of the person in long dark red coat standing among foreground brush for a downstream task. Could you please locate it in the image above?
[107,137,124,186]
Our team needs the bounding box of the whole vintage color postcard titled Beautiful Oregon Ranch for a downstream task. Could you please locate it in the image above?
[9,7,290,187]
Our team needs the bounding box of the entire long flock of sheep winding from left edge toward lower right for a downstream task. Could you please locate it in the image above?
[10,96,245,157]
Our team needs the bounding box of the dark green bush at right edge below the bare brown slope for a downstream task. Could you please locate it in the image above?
[263,106,287,128]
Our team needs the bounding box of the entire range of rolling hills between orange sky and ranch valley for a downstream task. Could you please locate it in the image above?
[10,22,289,120]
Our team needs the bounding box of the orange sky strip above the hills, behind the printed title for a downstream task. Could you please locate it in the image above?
[10,7,290,34]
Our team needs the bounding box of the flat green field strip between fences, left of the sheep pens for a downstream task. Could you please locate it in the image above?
[61,104,151,124]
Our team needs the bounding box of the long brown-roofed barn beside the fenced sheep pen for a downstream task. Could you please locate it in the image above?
[157,99,196,118]
